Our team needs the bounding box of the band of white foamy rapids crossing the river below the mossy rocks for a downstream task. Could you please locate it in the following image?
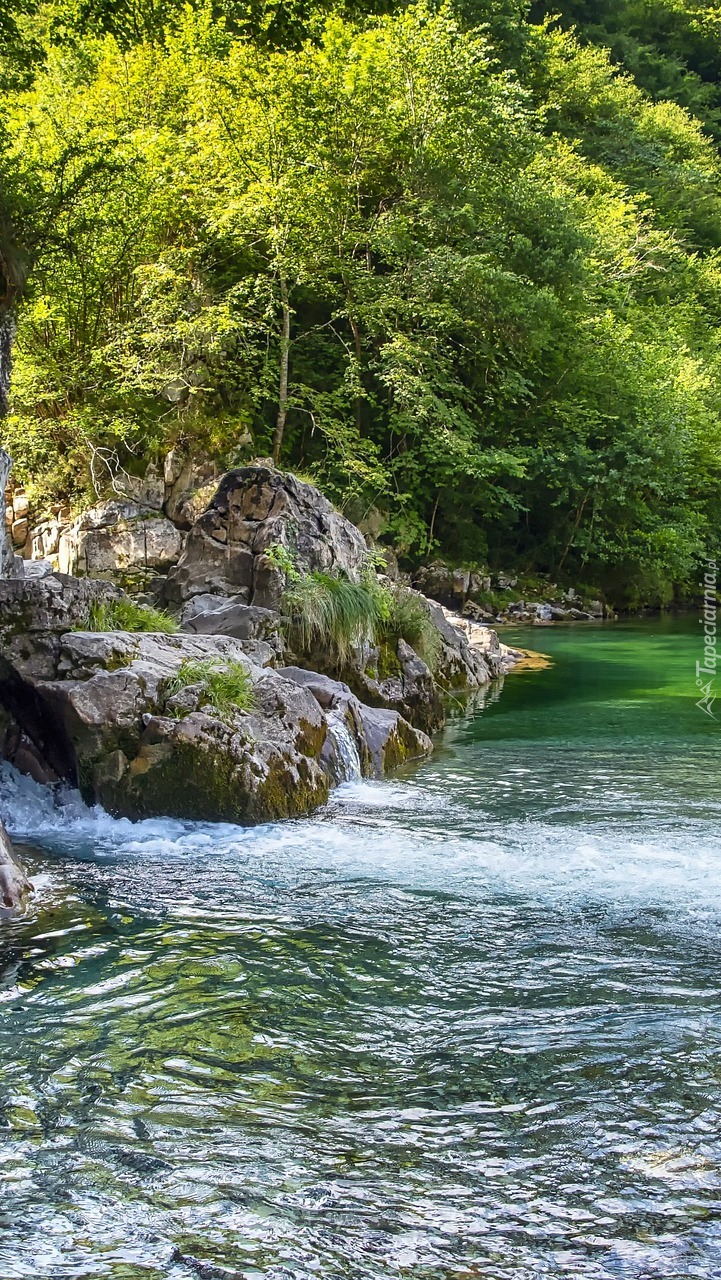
[0,765,721,915]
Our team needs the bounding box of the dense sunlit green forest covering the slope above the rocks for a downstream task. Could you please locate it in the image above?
[0,0,721,605]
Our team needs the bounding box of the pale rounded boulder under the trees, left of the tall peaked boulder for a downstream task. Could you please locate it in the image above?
[58,498,183,580]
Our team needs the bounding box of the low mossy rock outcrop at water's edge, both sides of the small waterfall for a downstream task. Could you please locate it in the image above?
[0,575,430,822]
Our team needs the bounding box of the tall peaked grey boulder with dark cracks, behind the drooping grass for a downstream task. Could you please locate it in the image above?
[164,466,368,609]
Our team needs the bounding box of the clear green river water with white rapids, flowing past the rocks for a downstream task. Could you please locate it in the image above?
[0,623,721,1280]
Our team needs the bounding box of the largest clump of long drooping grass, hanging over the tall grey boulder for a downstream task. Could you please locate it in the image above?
[283,573,388,667]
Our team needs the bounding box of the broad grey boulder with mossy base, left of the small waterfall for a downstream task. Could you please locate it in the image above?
[0,624,330,822]
